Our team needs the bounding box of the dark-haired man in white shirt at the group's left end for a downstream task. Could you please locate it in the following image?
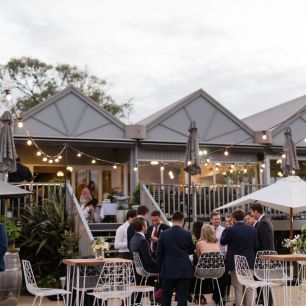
[115,209,136,259]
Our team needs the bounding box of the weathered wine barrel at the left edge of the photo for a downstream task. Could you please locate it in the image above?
[0,252,22,306]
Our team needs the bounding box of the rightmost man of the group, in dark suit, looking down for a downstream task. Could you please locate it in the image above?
[251,202,274,306]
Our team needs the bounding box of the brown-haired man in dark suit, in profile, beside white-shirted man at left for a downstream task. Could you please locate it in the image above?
[130,217,159,273]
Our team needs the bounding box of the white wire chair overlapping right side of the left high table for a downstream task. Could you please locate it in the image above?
[87,263,134,306]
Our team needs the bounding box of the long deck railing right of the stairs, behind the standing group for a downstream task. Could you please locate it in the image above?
[140,184,284,221]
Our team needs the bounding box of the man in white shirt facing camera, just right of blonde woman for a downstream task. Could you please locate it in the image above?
[210,211,228,305]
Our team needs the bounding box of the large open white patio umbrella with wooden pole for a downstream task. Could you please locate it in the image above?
[217,176,306,237]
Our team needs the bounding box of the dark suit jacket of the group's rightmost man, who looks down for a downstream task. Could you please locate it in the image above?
[255,215,274,251]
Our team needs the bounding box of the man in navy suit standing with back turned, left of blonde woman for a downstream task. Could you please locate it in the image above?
[156,212,194,306]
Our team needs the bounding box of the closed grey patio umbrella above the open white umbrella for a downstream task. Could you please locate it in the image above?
[281,127,300,176]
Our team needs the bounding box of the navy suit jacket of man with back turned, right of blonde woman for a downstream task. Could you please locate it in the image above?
[220,222,257,271]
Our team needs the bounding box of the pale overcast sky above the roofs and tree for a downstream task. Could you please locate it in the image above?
[0,0,306,122]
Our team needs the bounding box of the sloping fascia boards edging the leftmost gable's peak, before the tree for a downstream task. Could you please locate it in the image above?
[18,85,125,131]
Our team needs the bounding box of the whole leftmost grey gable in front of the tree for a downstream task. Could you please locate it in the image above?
[15,86,125,139]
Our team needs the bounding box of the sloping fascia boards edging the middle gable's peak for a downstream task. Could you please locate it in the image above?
[147,89,254,136]
